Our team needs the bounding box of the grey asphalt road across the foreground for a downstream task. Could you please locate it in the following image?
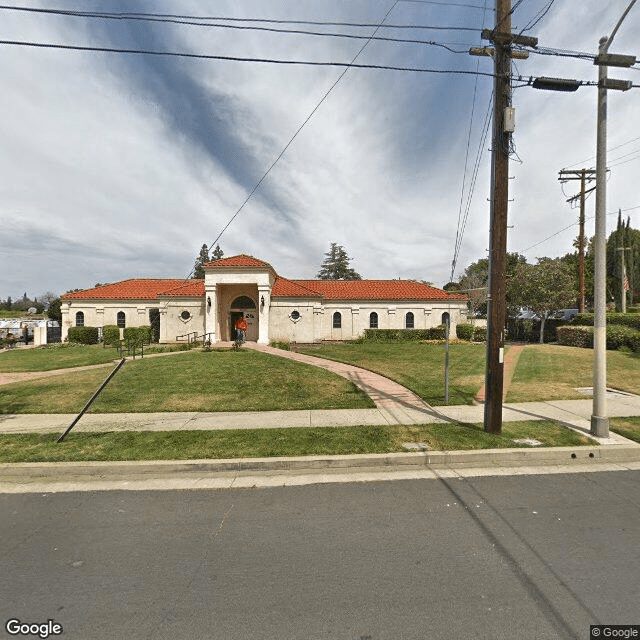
[0,471,640,640]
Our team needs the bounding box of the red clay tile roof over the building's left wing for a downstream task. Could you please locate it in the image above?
[60,278,204,300]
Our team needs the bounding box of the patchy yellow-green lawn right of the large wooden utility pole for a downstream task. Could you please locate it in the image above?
[507,345,640,402]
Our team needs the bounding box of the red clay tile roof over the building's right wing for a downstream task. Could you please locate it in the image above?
[271,278,466,300]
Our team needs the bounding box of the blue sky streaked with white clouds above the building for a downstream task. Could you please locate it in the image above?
[0,0,640,299]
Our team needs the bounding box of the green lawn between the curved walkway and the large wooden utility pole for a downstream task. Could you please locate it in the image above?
[300,342,485,406]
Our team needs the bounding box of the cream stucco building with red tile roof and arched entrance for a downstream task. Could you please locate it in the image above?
[61,254,467,344]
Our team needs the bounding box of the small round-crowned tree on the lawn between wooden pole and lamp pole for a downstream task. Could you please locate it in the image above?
[507,258,578,344]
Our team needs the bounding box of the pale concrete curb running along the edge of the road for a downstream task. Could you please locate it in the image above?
[0,445,640,483]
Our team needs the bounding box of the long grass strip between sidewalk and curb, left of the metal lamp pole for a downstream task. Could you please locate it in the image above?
[0,421,594,463]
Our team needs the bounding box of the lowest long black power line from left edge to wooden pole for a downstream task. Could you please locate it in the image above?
[0,40,494,78]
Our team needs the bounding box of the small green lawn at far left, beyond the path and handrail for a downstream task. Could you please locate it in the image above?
[0,343,118,373]
